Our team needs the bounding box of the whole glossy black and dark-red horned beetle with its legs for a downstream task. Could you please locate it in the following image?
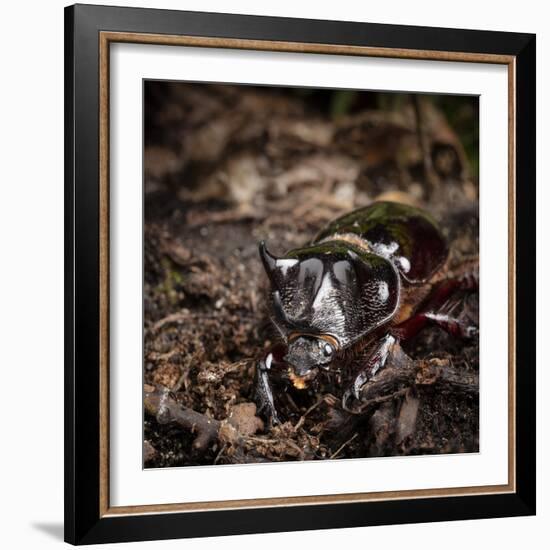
[255,201,478,424]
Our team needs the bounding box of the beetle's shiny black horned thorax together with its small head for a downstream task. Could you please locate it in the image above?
[260,241,400,358]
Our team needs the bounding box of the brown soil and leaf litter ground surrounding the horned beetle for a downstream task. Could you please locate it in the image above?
[144,83,479,467]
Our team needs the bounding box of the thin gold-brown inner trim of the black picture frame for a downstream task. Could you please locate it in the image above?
[99,31,516,517]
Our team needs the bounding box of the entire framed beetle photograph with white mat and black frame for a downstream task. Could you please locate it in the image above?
[65,5,535,544]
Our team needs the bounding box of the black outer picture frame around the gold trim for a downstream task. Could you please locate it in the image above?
[65,5,536,544]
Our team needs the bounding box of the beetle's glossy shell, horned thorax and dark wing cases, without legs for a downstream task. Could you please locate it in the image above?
[260,202,447,349]
